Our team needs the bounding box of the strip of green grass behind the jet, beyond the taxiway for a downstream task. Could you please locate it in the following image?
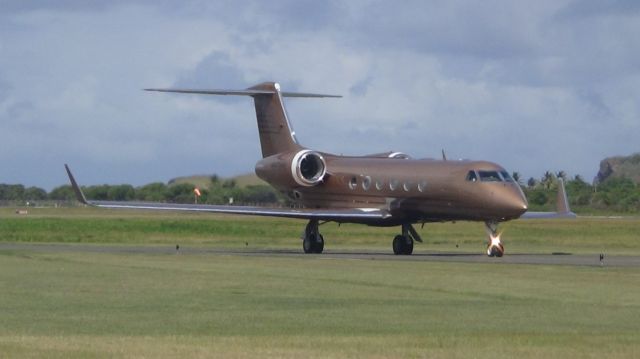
[0,208,640,255]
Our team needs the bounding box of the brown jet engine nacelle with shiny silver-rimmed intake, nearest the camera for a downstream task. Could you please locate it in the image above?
[256,149,327,187]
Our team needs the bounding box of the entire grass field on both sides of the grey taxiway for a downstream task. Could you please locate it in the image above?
[0,209,640,358]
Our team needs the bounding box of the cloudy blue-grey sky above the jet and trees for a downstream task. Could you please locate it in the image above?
[0,0,640,190]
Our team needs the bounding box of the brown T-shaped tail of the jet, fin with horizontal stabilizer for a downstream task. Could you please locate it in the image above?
[145,82,342,157]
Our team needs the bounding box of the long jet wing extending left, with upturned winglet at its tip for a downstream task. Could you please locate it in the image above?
[64,164,391,222]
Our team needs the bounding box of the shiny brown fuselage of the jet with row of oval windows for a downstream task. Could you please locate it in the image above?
[256,153,527,226]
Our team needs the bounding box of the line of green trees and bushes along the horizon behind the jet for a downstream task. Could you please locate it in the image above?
[0,171,640,213]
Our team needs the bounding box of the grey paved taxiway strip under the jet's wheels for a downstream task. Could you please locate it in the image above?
[0,243,640,267]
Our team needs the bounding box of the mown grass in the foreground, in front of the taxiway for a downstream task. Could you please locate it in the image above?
[0,251,640,357]
